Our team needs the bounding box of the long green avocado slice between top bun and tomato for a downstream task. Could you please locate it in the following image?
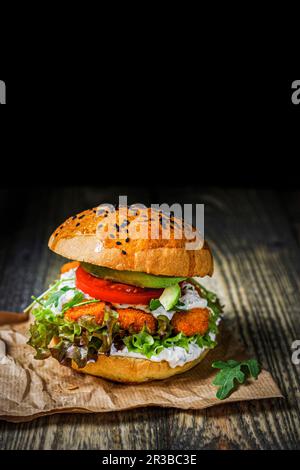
[81,263,186,289]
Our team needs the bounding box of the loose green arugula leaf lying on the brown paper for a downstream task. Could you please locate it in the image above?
[212,359,261,400]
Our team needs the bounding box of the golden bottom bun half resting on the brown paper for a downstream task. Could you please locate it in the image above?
[72,349,209,383]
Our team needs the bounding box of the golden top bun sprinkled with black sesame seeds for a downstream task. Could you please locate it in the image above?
[48,205,213,277]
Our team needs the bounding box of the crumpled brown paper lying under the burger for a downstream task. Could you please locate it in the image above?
[0,322,282,422]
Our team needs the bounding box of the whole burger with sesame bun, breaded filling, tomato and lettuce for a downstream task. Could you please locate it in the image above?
[26,206,222,383]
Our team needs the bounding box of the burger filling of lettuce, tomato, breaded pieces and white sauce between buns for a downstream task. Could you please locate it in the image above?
[28,262,222,368]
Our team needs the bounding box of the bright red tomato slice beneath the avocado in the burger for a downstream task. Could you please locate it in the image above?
[76,266,163,305]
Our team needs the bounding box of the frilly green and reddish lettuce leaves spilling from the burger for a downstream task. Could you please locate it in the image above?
[28,279,222,368]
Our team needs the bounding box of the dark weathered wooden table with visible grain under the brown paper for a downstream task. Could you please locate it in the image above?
[0,187,300,450]
